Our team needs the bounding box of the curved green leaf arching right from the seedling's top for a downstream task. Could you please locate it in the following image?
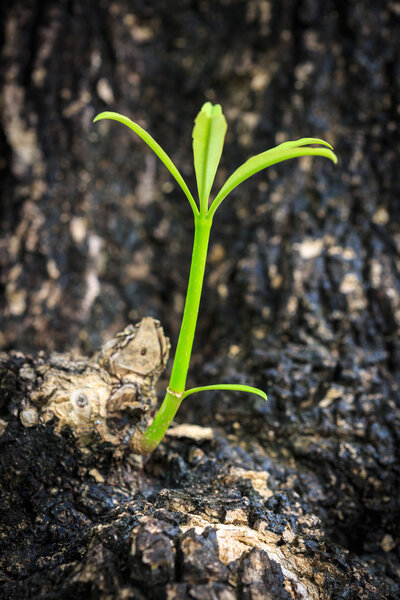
[209,138,337,218]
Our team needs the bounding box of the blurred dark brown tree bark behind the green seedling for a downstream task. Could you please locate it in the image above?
[0,0,400,574]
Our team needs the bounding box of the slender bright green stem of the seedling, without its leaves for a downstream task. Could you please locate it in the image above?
[141,215,212,454]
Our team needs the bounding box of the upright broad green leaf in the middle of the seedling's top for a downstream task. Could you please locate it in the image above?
[193,102,227,214]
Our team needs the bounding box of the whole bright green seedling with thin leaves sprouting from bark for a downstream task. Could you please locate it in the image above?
[94,102,337,454]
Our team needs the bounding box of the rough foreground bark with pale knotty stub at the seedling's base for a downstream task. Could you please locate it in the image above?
[0,332,399,600]
